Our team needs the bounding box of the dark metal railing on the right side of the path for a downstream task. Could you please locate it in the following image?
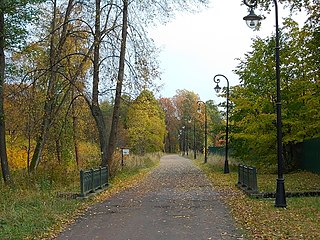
[238,164,259,193]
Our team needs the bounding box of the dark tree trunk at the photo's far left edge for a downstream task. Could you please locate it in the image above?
[0,0,10,183]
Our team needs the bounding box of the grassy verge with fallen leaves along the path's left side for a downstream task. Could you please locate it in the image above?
[0,156,159,240]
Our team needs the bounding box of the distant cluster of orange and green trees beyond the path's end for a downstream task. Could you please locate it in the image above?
[159,90,223,153]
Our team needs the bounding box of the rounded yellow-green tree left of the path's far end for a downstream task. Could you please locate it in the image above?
[127,90,166,154]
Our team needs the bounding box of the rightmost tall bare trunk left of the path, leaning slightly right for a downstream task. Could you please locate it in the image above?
[107,0,128,170]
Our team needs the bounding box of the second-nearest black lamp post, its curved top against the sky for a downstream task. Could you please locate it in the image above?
[213,74,230,173]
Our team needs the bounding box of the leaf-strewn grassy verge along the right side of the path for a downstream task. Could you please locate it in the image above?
[196,157,320,239]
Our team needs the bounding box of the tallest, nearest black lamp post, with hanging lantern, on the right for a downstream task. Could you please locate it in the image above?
[243,0,287,207]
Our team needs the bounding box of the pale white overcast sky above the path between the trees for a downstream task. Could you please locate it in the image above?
[149,0,304,104]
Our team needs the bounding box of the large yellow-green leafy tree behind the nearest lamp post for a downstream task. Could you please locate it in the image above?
[231,19,320,169]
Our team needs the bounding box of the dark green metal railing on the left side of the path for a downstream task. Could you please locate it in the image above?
[80,167,108,197]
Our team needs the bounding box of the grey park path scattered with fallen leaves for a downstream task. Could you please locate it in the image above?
[56,155,243,240]
